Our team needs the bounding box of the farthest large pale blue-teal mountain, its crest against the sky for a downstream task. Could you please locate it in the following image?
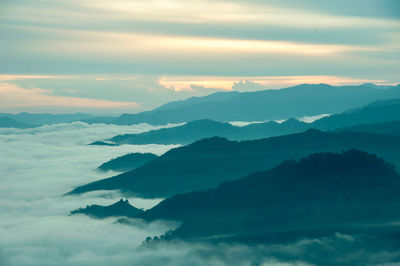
[112,84,400,125]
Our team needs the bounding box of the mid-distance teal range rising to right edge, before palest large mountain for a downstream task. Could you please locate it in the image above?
[92,99,400,145]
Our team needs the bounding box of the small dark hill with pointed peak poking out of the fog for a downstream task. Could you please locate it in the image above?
[71,199,143,219]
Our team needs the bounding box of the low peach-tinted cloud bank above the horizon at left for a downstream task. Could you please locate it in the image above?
[0,74,208,112]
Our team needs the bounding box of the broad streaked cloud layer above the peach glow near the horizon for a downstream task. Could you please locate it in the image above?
[0,0,400,82]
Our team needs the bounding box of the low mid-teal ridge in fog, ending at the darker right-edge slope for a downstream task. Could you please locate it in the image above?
[97,119,310,145]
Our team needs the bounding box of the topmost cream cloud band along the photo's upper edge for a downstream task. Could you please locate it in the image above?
[10,0,396,28]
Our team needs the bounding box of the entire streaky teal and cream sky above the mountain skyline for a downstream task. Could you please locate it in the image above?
[0,0,400,114]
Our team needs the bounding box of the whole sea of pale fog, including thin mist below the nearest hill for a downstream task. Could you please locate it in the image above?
[0,122,390,266]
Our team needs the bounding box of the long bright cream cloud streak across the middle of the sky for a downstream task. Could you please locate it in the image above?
[7,26,384,59]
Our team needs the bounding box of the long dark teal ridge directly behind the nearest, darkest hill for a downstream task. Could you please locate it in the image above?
[68,130,400,198]
